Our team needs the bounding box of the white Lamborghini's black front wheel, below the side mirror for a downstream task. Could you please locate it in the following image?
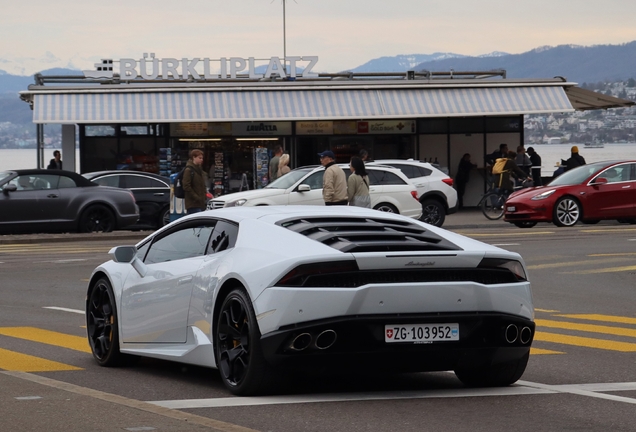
[86,277,139,366]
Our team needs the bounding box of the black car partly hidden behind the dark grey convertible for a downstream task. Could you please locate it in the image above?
[82,170,170,229]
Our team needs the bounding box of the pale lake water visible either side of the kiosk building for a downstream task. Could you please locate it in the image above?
[0,143,636,177]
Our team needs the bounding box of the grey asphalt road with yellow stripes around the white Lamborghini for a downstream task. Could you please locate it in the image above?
[0,223,636,432]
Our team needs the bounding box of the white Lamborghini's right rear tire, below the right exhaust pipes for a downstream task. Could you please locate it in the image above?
[455,352,530,387]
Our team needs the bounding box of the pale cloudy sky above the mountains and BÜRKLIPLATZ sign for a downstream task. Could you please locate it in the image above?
[0,0,636,75]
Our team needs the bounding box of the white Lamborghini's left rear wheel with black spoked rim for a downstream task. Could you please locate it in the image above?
[214,288,275,396]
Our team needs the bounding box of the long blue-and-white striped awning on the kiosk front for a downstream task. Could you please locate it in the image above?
[32,85,574,124]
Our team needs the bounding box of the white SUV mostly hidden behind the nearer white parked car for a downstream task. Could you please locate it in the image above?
[366,159,457,227]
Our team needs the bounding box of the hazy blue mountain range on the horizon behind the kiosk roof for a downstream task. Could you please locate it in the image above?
[0,41,636,124]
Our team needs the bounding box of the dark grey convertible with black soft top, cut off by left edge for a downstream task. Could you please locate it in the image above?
[0,169,139,233]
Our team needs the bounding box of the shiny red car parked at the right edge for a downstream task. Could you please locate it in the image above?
[504,161,636,228]
